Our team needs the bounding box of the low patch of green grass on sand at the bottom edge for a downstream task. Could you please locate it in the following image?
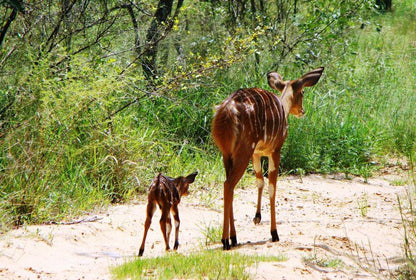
[112,250,287,279]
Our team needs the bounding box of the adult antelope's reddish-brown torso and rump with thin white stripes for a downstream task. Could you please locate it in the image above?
[212,88,287,153]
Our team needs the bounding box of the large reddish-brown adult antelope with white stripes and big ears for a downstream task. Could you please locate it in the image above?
[212,67,324,250]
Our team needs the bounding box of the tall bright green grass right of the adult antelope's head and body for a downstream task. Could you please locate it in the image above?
[276,2,416,176]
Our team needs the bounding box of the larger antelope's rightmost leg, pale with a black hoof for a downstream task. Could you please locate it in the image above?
[269,151,280,242]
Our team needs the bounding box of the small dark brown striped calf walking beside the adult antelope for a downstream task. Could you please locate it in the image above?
[139,172,198,256]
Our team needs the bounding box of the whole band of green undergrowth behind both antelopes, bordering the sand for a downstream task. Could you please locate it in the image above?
[0,1,416,232]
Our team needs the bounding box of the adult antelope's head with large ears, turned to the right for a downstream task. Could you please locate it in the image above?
[267,67,324,118]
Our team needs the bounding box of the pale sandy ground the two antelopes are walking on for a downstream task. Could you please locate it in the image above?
[0,175,408,279]
